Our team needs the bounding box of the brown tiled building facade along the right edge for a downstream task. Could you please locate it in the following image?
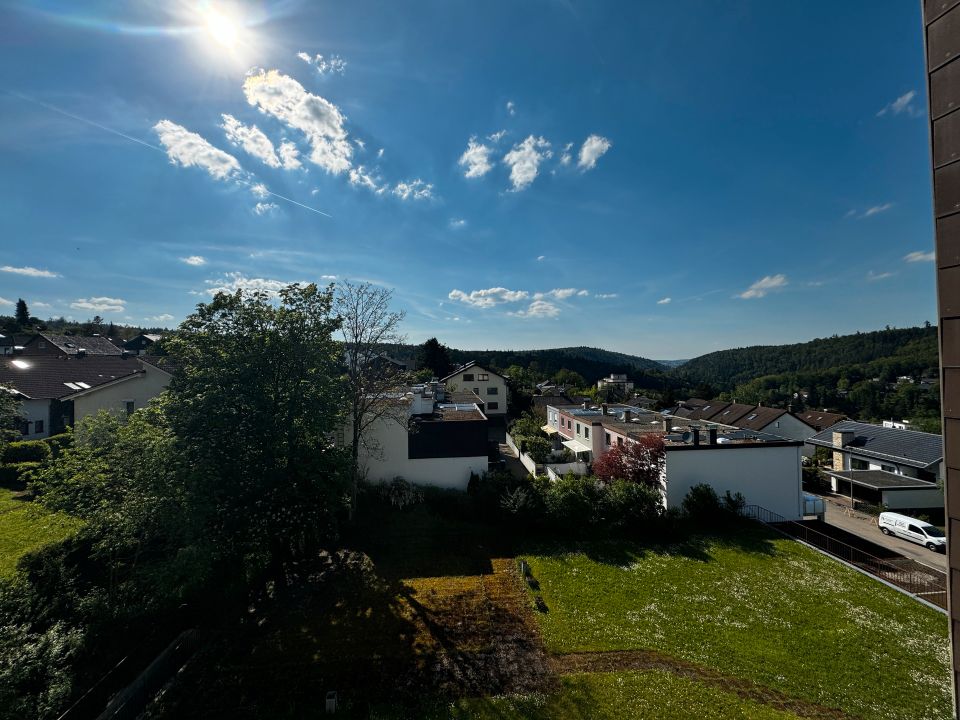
[923,0,960,715]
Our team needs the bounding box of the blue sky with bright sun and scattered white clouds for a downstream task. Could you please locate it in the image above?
[0,0,936,358]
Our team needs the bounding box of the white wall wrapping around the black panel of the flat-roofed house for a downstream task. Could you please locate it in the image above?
[360,418,489,490]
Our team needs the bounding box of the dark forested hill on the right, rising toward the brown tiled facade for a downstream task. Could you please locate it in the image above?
[673,326,938,390]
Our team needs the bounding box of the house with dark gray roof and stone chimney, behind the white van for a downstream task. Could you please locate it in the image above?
[807,420,944,509]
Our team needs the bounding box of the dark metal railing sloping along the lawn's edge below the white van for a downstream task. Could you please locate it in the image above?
[741,505,947,610]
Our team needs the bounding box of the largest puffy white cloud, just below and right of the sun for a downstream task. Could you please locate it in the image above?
[243,70,353,174]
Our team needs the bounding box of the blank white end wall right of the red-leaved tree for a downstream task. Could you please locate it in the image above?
[666,445,802,520]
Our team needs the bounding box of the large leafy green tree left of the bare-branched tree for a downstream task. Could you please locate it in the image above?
[166,284,345,570]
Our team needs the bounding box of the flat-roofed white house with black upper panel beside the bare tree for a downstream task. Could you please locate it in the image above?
[346,383,489,490]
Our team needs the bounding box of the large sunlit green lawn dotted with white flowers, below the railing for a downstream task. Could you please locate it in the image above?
[524,526,950,720]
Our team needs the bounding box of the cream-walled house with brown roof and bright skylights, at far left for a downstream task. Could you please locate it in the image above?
[0,354,171,440]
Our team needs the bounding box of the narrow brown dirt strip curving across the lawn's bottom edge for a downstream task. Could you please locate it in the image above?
[550,650,856,720]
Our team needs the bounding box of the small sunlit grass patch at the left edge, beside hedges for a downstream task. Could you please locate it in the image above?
[0,488,83,578]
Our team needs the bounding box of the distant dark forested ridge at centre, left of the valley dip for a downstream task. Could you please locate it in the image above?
[450,347,667,383]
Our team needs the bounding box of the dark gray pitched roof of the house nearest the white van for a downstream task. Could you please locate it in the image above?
[807,420,943,468]
